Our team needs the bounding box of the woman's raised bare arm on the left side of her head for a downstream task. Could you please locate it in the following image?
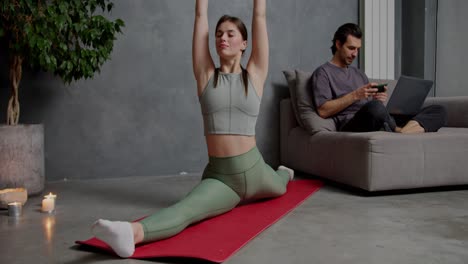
[192,0,214,89]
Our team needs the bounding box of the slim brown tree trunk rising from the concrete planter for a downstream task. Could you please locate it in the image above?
[7,55,23,125]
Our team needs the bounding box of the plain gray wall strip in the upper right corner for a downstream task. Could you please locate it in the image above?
[436,0,468,96]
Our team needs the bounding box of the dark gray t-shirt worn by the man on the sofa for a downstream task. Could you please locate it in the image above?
[311,62,369,127]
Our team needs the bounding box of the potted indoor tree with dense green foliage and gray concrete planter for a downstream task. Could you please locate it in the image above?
[0,0,124,202]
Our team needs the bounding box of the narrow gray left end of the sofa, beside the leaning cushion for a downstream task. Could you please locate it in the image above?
[280,98,299,160]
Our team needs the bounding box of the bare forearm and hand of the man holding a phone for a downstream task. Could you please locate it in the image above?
[317,83,377,118]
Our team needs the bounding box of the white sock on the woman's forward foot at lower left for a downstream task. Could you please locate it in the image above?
[92,219,135,258]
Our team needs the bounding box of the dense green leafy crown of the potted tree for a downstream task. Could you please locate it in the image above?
[0,0,125,83]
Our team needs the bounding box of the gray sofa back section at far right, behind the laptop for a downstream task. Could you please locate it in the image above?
[424,96,468,127]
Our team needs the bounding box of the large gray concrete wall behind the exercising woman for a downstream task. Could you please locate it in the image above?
[0,0,358,181]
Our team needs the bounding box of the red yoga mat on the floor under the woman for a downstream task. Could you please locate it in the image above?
[76,180,322,263]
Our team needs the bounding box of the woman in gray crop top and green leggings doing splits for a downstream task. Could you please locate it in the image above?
[93,0,294,257]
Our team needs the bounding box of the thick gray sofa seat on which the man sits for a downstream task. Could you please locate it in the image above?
[281,127,468,191]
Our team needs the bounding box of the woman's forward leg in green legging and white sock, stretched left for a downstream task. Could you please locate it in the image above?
[93,179,240,257]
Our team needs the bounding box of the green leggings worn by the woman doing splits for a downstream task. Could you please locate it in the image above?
[140,147,289,242]
